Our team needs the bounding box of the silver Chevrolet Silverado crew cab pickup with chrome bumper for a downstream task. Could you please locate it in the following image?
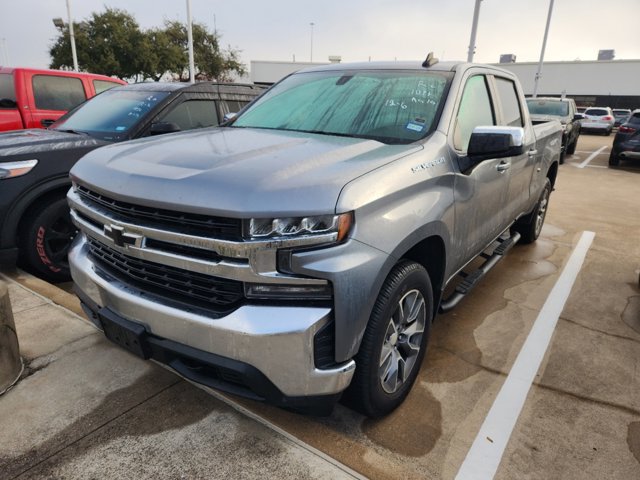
[68,57,561,417]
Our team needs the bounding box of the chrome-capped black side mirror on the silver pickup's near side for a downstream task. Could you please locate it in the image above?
[467,126,524,164]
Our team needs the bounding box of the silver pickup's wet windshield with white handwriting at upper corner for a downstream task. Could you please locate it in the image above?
[232,70,449,143]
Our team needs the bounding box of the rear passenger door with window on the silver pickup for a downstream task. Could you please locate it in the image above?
[491,76,539,223]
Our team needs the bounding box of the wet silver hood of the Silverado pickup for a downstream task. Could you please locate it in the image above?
[71,128,422,218]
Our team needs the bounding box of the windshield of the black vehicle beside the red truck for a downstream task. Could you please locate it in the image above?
[51,90,169,140]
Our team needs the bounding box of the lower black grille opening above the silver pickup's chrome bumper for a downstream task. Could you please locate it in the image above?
[88,238,244,313]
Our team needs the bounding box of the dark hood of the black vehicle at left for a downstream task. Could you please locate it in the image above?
[0,128,107,157]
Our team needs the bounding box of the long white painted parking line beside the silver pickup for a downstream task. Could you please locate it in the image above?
[456,232,596,480]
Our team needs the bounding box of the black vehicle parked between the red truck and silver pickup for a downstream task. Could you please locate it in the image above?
[0,83,263,280]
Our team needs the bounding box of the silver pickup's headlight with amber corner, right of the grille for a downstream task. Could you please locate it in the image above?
[248,212,353,242]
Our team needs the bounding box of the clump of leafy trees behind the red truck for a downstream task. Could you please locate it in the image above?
[49,8,246,81]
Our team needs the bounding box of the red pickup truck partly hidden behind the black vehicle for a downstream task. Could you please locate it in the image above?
[0,67,126,131]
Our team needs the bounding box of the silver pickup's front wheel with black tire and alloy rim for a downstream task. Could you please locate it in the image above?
[345,260,433,418]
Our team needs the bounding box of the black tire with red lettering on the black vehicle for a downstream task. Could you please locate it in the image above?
[20,198,77,282]
